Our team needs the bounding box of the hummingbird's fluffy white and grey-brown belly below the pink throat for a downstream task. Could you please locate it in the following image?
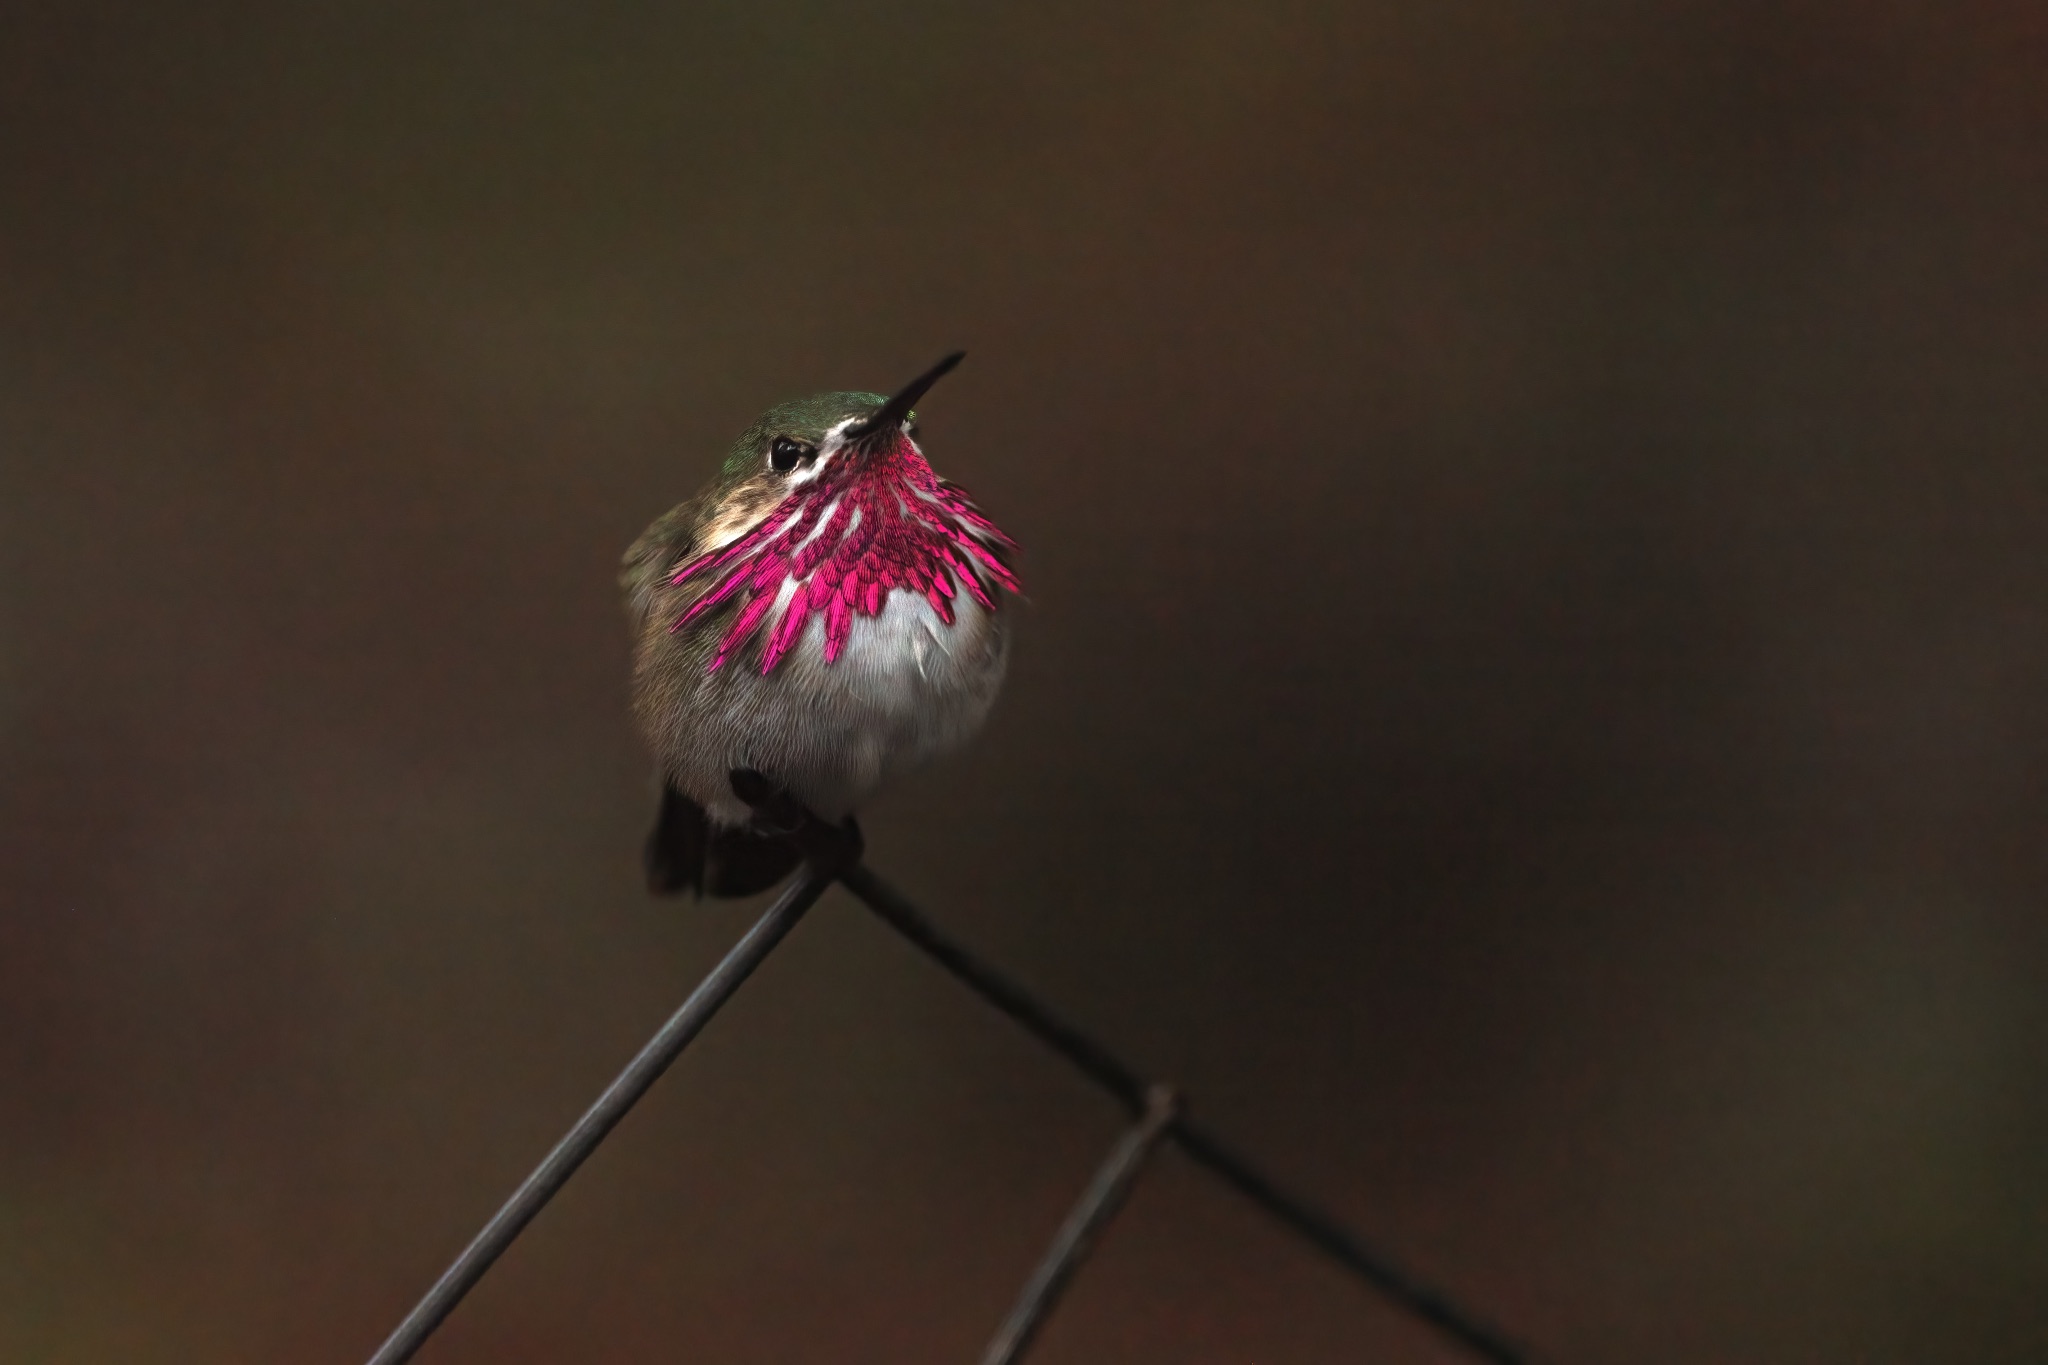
[666,589,1008,825]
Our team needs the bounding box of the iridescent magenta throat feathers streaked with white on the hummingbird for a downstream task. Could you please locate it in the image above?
[670,436,1018,673]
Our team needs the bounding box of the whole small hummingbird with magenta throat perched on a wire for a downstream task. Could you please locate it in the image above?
[618,352,1018,896]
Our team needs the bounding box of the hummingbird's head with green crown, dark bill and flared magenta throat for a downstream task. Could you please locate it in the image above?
[670,352,1016,673]
